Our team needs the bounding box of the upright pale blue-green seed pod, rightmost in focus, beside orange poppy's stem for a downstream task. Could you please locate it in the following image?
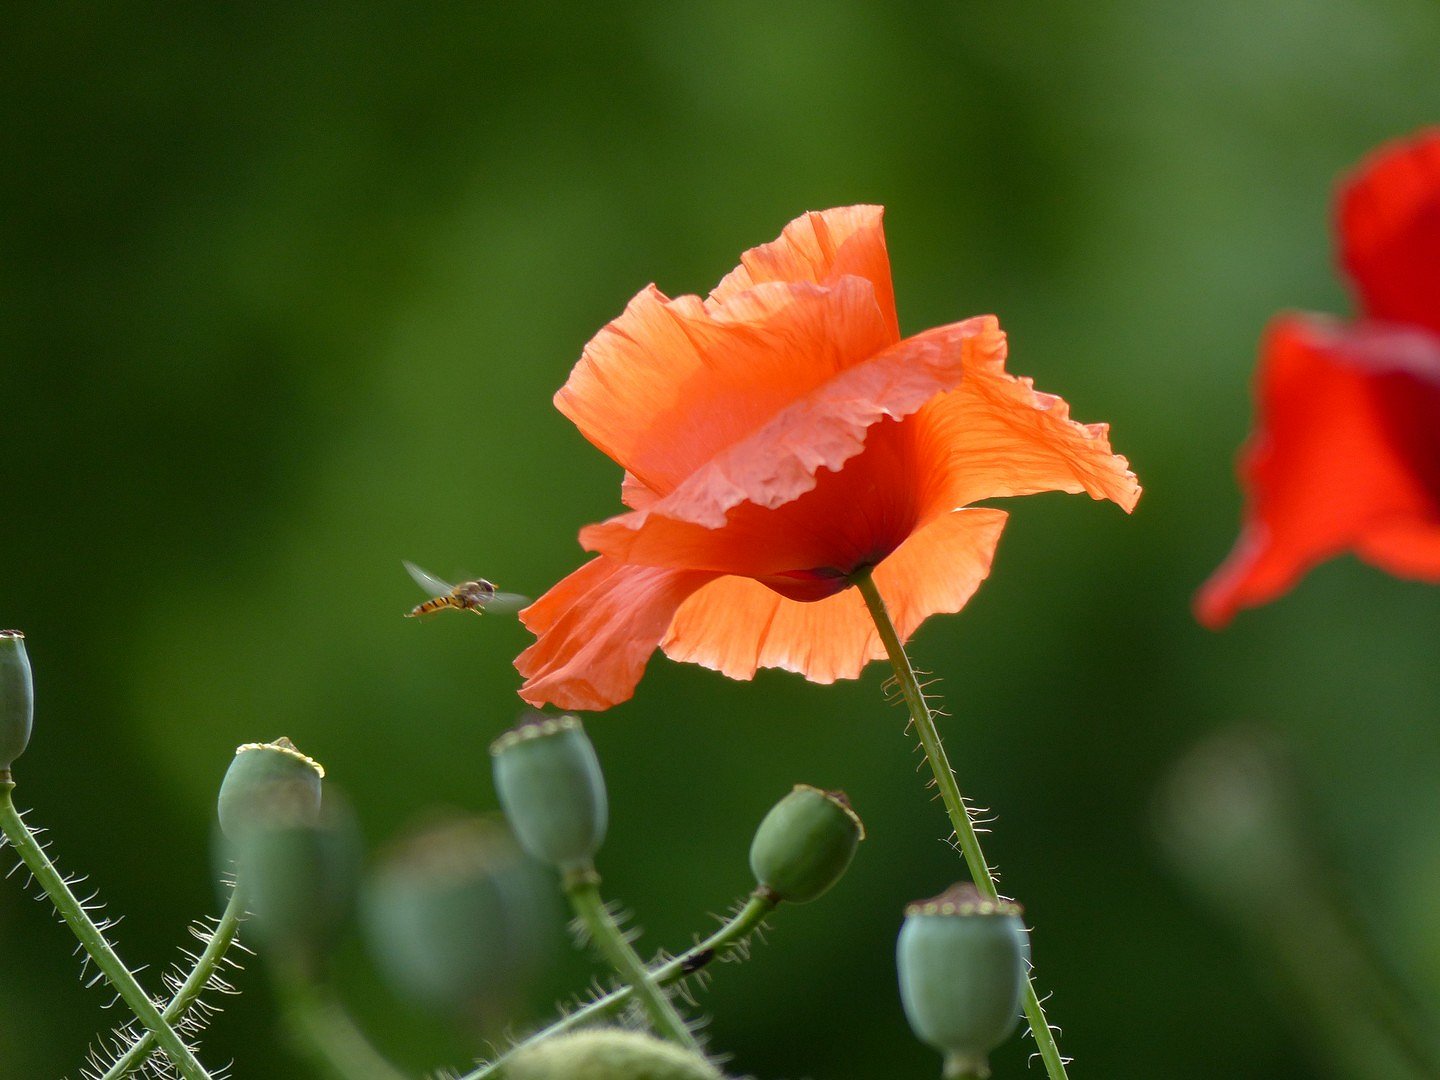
[896,883,1030,1080]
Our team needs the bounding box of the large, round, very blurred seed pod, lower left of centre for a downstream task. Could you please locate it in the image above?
[361,818,554,1017]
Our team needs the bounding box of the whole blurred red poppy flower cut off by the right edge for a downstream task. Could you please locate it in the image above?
[1195,130,1440,628]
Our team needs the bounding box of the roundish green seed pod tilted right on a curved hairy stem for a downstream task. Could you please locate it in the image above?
[750,783,865,904]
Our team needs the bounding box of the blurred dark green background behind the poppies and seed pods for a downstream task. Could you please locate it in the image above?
[0,0,1440,1080]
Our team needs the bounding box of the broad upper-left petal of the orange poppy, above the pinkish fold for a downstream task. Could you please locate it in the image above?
[554,276,893,494]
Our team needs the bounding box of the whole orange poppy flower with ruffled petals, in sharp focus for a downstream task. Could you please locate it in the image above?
[516,206,1139,708]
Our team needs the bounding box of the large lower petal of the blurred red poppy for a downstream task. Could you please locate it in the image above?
[1195,315,1440,628]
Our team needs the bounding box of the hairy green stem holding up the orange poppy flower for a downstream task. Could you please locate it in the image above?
[854,573,1067,1080]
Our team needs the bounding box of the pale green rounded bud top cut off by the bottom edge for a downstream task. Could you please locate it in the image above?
[505,1028,724,1080]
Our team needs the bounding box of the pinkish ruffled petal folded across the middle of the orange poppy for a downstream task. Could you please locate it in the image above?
[580,315,1005,577]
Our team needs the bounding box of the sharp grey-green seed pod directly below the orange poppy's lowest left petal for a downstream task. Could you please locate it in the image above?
[490,714,609,871]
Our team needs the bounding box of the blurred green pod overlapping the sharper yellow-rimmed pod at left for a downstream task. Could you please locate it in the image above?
[232,791,360,966]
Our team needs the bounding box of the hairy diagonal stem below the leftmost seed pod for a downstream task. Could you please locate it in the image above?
[0,779,210,1080]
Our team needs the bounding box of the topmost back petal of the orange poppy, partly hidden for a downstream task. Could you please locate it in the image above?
[708,206,900,341]
